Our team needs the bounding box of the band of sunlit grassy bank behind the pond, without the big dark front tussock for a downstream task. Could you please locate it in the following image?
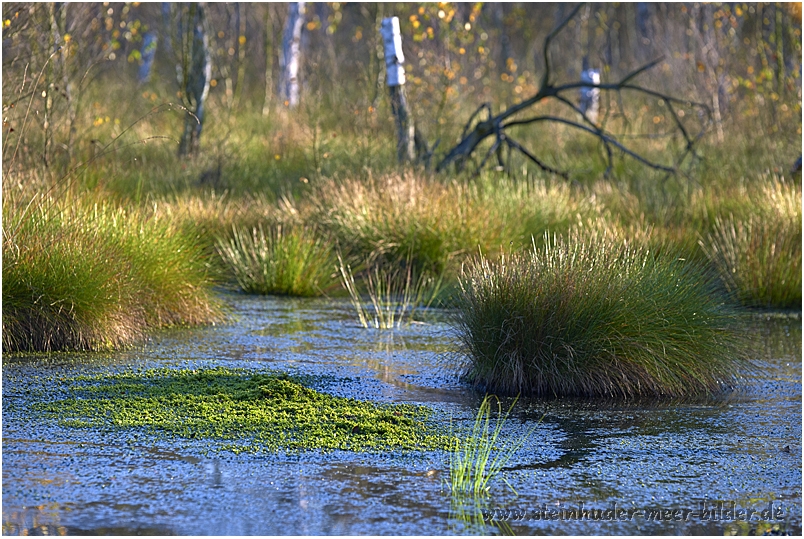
[3,172,801,352]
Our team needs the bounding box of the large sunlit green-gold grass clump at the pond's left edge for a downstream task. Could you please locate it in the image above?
[3,197,223,352]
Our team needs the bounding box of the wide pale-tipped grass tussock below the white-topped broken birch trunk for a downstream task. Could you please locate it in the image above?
[314,172,599,275]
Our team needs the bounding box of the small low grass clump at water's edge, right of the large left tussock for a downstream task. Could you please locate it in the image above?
[218,225,337,297]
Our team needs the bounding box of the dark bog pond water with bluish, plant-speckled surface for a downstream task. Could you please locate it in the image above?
[2,295,802,535]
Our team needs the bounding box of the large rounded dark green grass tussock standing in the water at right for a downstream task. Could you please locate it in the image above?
[456,235,747,398]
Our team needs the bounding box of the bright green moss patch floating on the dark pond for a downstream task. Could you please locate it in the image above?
[39,367,449,452]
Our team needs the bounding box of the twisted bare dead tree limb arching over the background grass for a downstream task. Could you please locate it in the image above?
[436,4,711,179]
